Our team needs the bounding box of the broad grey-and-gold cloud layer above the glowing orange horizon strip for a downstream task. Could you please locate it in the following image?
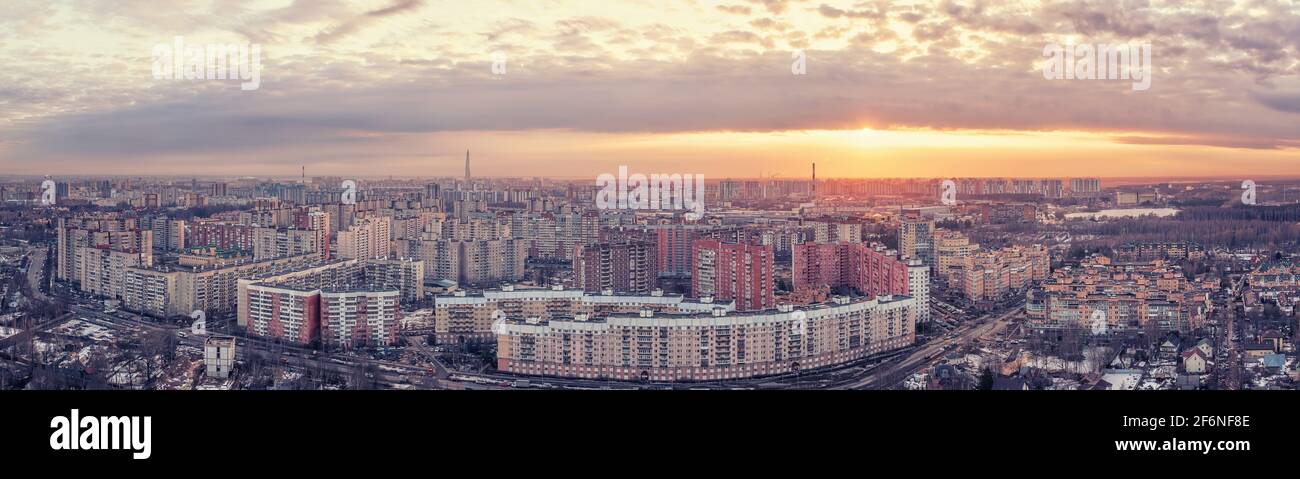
[0,0,1300,173]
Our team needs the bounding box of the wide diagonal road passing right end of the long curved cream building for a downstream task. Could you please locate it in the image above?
[832,308,1022,389]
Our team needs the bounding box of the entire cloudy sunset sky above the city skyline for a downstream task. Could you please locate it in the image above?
[0,0,1300,178]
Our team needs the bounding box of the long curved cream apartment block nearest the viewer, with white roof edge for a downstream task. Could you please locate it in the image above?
[497,297,915,381]
